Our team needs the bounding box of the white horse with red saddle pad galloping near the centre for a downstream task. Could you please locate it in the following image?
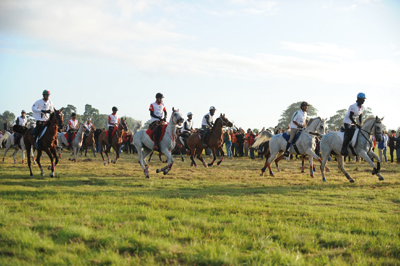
[133,108,183,178]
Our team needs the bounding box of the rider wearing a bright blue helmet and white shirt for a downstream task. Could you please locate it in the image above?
[340,92,366,156]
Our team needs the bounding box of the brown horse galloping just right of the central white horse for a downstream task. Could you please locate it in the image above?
[187,114,233,167]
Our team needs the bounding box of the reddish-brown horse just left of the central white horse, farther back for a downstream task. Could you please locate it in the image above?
[99,118,128,165]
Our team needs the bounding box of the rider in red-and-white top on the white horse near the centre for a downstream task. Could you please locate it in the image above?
[149,93,167,150]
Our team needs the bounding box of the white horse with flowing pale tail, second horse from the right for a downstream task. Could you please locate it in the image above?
[252,117,326,177]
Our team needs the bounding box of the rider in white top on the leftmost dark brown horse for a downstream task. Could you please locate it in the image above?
[31,90,54,148]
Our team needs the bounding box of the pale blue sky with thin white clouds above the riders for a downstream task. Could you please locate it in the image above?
[0,0,400,129]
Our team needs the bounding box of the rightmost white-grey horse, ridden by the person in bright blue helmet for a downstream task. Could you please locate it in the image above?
[320,117,384,183]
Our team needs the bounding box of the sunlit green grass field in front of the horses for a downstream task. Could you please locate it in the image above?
[0,150,400,265]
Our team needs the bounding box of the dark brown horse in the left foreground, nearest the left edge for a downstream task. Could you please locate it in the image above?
[24,108,64,177]
